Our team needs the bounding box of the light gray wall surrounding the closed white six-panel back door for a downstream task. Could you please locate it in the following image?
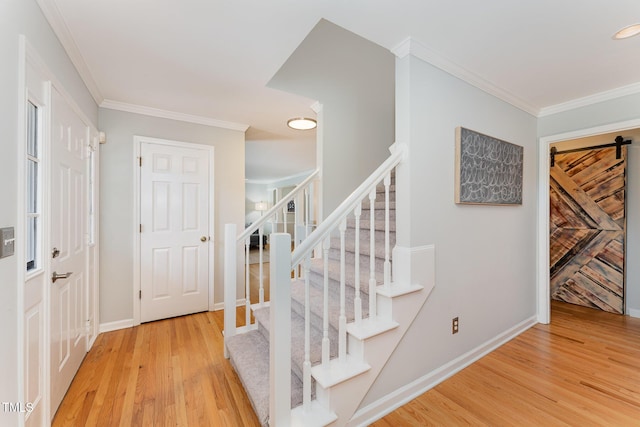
[99,108,245,324]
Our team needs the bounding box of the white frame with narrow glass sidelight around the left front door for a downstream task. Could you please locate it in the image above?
[15,35,99,426]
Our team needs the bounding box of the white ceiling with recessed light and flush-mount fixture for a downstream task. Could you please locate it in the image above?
[37,0,640,180]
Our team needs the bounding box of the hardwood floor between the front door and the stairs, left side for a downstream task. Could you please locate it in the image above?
[53,310,259,427]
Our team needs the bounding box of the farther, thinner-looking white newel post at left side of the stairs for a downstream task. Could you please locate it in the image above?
[224,224,238,359]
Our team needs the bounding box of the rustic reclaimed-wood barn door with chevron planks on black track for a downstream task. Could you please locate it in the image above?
[549,147,627,314]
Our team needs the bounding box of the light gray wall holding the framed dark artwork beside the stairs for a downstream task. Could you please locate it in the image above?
[361,55,537,407]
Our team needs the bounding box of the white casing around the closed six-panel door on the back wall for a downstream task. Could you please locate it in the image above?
[131,135,216,326]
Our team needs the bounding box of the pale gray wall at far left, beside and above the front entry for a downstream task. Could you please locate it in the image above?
[0,0,98,426]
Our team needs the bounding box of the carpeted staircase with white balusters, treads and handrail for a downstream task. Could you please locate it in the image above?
[225,145,430,426]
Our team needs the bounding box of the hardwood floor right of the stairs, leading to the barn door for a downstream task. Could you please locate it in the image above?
[373,301,640,427]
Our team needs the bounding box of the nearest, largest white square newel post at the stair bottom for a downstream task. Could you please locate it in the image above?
[269,233,291,426]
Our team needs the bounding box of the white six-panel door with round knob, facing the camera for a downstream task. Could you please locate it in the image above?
[140,141,213,322]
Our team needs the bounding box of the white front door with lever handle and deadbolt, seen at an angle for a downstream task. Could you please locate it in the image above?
[49,88,89,416]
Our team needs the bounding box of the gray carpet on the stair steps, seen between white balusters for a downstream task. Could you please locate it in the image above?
[227,177,395,426]
